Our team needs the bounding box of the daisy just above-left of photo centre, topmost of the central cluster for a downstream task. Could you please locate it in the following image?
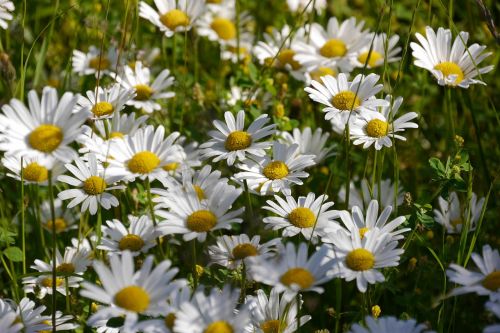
[200,110,275,165]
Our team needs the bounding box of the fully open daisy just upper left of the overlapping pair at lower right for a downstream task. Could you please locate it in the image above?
[262,193,339,243]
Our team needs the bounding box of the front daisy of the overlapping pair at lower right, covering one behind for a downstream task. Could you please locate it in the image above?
[330,228,404,293]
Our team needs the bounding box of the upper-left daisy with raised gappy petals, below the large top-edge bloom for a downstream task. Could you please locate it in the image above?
[116,61,175,113]
